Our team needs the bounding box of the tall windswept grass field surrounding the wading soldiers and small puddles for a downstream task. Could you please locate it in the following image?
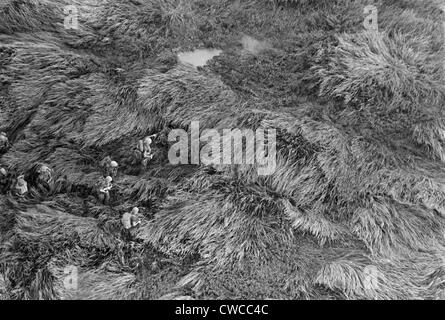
[0,0,445,299]
